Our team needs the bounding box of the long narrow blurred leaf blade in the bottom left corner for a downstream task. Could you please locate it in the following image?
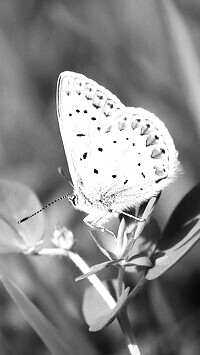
[1,276,77,355]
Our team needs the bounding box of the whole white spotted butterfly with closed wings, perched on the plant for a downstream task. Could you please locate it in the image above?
[57,71,180,227]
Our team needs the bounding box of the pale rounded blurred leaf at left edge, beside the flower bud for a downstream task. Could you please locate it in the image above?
[0,180,44,254]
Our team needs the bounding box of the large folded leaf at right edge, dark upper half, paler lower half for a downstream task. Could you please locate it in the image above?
[146,184,200,280]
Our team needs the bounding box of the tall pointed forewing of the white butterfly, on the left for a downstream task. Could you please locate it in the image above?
[57,71,124,202]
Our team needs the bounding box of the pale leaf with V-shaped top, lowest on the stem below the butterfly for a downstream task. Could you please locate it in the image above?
[83,286,130,331]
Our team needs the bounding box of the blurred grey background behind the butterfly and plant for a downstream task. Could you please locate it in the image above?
[0,0,200,355]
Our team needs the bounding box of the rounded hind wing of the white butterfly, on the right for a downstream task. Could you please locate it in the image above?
[93,108,181,212]
